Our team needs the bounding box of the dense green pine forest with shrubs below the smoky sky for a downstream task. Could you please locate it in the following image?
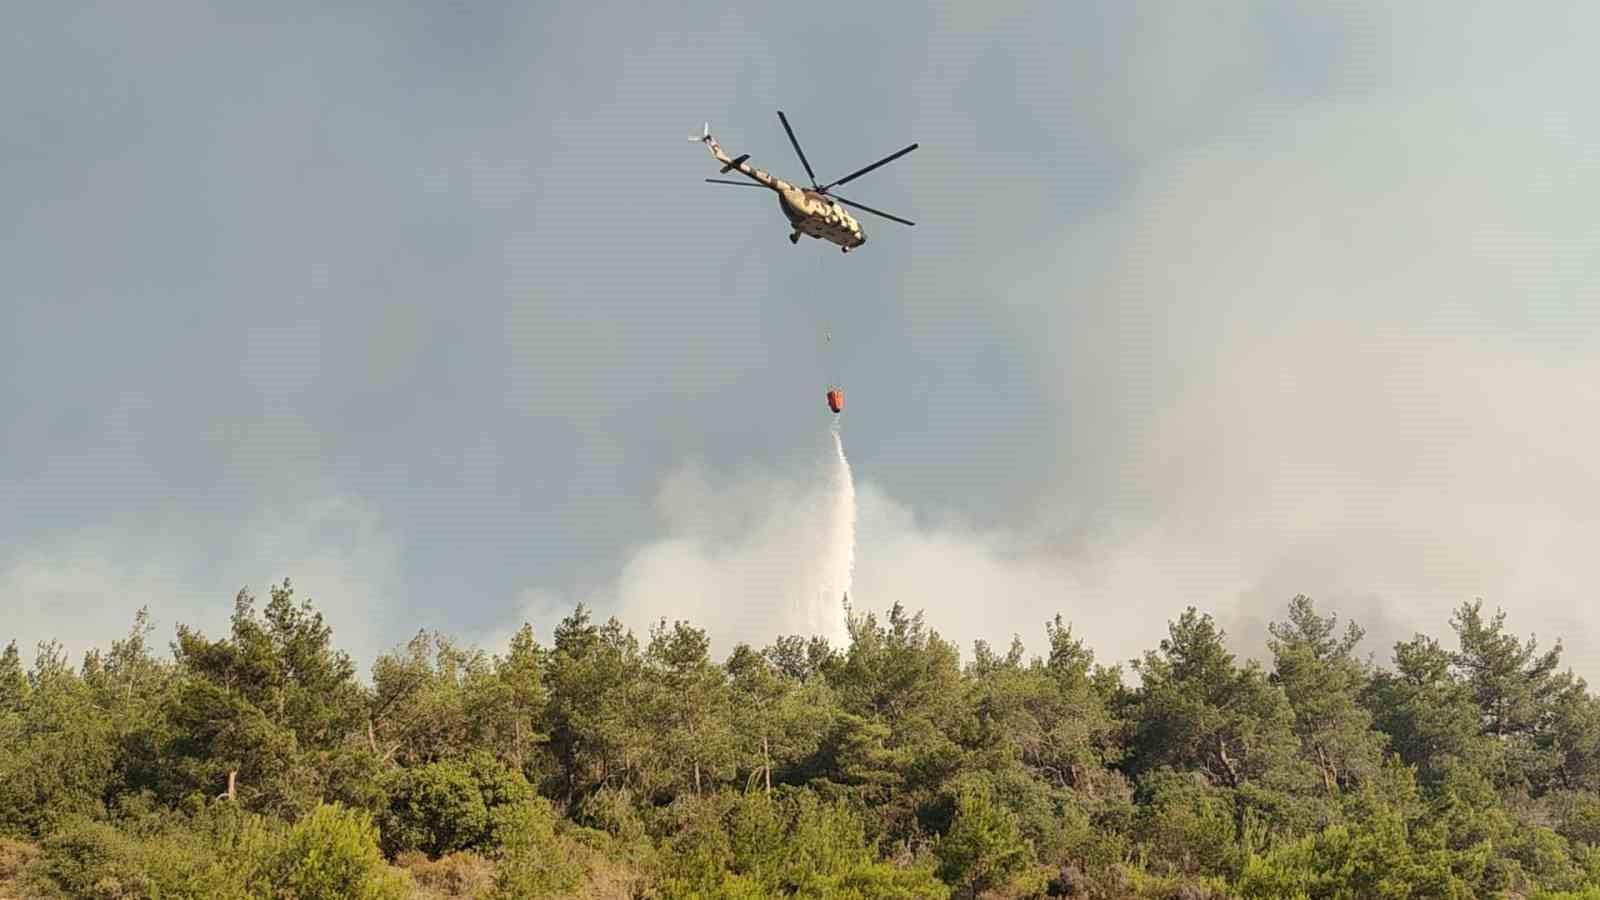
[0,580,1600,900]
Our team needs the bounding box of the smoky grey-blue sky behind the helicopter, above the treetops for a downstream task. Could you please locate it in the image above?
[0,0,1600,679]
